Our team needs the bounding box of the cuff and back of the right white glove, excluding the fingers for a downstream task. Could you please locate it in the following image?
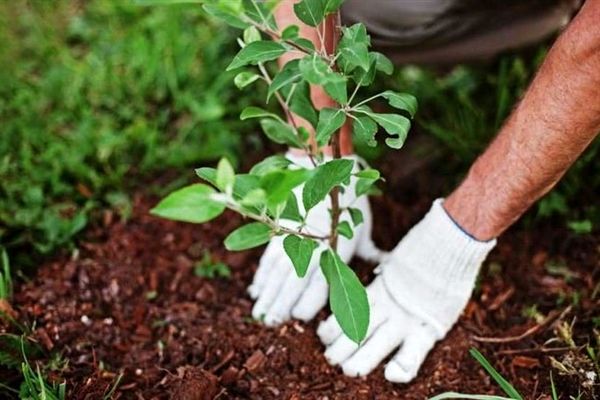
[382,199,496,338]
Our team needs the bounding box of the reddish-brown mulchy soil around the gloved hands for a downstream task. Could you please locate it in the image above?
[4,152,600,400]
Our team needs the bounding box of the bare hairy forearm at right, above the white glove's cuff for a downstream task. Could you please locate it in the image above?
[444,0,600,240]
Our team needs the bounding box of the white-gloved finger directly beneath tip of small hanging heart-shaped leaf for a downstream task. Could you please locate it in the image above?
[265,263,317,326]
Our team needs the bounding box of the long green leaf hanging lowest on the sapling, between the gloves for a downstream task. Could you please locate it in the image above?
[321,250,369,344]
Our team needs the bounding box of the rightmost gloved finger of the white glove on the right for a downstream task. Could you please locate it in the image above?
[385,324,436,383]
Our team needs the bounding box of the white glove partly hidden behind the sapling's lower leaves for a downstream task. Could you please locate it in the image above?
[248,153,383,326]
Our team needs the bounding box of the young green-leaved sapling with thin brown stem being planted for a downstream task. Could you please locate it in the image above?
[152,0,417,343]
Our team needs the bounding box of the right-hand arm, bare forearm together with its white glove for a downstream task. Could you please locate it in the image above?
[318,0,600,382]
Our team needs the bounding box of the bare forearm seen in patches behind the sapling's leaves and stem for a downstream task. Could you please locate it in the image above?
[274,0,352,155]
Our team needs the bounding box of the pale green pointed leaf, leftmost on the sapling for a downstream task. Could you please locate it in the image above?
[150,183,225,223]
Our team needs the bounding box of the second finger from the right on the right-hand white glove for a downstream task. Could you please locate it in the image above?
[342,319,406,376]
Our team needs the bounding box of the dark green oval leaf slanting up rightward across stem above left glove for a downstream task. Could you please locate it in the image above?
[302,159,354,212]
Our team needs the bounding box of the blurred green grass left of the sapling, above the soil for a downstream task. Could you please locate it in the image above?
[0,0,254,261]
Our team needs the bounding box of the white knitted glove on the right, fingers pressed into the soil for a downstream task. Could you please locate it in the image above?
[317,199,496,383]
